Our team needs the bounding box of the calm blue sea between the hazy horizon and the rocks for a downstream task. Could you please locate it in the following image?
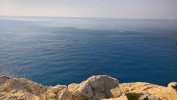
[0,17,177,85]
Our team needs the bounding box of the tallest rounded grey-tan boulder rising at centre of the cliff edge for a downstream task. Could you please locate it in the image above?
[70,75,121,100]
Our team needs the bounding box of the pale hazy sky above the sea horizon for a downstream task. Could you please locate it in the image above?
[0,0,177,19]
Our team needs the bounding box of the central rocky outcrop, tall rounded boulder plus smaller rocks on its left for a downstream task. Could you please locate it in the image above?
[46,75,121,100]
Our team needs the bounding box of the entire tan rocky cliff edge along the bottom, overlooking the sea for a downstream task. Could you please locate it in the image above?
[0,75,177,100]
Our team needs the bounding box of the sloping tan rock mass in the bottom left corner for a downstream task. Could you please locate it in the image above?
[0,77,46,100]
